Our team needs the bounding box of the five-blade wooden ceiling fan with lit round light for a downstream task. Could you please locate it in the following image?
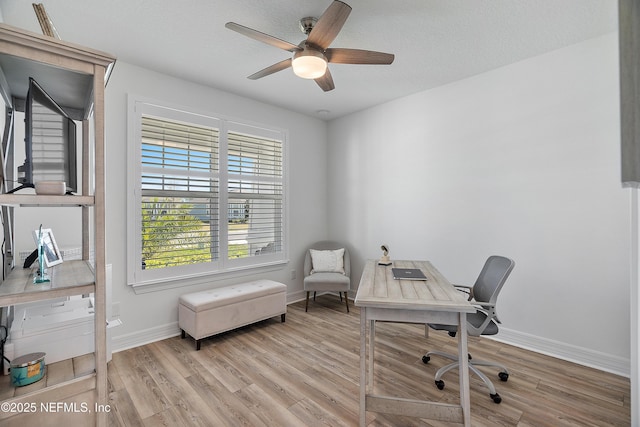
[225,0,394,92]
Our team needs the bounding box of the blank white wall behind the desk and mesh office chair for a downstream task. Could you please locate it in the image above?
[328,34,630,375]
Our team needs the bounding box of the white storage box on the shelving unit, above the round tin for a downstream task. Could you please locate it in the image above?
[5,298,94,370]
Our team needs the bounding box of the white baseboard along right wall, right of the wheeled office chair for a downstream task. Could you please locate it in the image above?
[487,327,631,378]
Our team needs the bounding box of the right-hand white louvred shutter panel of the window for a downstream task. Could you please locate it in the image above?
[227,131,284,258]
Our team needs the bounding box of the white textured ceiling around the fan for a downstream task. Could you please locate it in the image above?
[0,0,617,119]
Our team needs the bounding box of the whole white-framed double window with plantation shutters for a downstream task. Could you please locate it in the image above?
[127,100,286,286]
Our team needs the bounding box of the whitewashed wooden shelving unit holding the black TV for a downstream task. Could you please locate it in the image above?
[0,24,115,426]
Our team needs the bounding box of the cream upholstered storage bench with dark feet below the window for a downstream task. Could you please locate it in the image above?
[178,280,287,350]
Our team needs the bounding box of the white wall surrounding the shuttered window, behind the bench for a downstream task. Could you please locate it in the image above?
[106,62,328,350]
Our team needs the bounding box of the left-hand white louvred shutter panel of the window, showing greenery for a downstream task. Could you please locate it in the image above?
[141,115,219,269]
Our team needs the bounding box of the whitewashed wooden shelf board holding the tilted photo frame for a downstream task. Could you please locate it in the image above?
[0,260,95,307]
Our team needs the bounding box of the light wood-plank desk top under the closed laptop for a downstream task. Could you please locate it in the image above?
[355,260,476,313]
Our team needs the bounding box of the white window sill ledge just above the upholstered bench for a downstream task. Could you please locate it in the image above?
[130,260,289,294]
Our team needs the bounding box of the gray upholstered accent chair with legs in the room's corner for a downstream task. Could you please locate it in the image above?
[303,241,351,313]
